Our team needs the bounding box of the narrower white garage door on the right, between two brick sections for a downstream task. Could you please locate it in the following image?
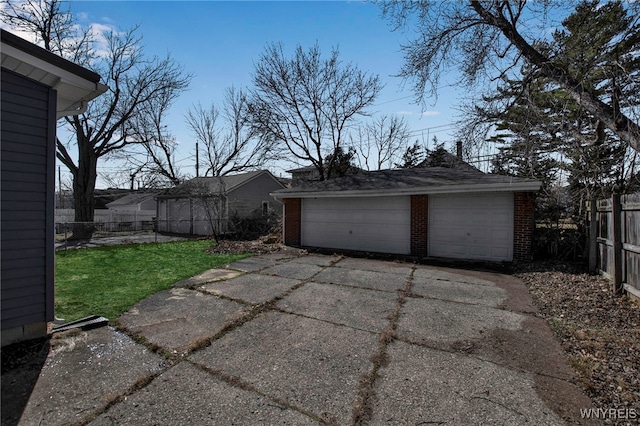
[428,193,513,261]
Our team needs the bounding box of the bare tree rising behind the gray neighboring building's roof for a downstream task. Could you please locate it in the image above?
[185,87,278,176]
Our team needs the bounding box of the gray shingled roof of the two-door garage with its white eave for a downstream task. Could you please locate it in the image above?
[272,167,541,199]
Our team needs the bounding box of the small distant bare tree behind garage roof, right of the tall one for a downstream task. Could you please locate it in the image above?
[355,115,410,170]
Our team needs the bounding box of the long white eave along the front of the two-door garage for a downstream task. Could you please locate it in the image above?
[270,181,541,200]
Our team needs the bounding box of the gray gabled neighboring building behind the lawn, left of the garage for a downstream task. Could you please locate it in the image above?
[156,170,284,235]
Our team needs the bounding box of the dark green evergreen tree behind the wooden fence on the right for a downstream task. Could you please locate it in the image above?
[474,1,640,223]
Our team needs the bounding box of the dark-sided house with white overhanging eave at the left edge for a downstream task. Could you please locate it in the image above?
[0,30,107,346]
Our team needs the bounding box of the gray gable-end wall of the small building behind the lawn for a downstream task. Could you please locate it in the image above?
[228,173,284,217]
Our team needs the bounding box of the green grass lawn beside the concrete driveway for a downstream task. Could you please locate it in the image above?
[55,240,249,321]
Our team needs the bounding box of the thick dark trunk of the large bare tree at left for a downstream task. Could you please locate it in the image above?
[71,141,98,240]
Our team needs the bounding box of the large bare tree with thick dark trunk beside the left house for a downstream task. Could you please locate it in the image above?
[3,0,190,238]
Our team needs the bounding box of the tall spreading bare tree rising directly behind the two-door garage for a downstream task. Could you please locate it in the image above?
[249,44,382,180]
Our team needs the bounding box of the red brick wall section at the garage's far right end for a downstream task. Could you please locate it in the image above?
[513,192,535,261]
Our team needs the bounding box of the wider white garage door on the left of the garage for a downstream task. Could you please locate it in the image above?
[301,196,411,254]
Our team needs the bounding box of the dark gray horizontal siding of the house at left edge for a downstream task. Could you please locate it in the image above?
[0,69,56,345]
